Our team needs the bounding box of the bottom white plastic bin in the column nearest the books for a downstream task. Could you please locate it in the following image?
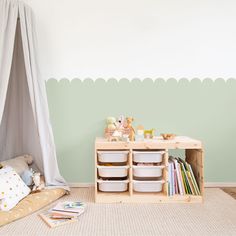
[133,180,165,192]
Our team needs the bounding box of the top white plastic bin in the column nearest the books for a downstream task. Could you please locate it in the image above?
[133,151,165,163]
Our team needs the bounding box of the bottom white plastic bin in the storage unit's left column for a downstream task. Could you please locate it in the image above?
[98,180,129,192]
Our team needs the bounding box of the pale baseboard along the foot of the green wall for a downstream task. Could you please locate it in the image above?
[68,182,236,188]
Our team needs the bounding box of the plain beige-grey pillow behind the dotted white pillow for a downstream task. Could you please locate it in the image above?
[1,155,33,175]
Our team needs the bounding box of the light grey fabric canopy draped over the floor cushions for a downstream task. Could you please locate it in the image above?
[0,0,68,189]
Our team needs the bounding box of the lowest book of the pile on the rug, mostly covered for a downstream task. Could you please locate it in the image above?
[39,211,78,228]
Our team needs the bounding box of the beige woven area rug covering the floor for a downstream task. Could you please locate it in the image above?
[0,188,236,236]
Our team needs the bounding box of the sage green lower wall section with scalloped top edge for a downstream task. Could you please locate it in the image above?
[46,79,236,183]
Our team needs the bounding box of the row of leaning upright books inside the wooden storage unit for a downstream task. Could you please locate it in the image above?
[168,157,201,196]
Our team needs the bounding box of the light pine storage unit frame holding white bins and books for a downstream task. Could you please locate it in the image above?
[95,136,204,203]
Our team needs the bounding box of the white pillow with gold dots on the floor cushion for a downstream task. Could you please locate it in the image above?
[0,166,30,211]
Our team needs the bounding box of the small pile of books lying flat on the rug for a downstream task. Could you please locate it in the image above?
[39,202,86,228]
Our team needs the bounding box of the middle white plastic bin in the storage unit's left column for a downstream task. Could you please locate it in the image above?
[97,166,129,178]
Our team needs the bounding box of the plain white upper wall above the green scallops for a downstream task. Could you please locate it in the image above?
[25,0,236,79]
